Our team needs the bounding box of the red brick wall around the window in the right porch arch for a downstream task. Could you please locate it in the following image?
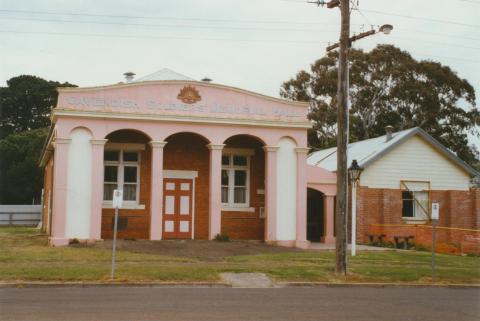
[222,136,265,240]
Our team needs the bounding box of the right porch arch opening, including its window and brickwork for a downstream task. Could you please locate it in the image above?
[221,135,265,240]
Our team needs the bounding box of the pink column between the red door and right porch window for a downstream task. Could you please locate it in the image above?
[207,144,225,240]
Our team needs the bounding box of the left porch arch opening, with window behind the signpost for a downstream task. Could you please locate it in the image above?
[102,129,152,239]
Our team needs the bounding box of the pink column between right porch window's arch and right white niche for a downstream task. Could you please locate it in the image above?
[263,146,278,243]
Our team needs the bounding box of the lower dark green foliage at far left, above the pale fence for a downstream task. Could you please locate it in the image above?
[0,128,48,204]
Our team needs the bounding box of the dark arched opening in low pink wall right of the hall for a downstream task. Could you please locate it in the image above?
[307,188,325,242]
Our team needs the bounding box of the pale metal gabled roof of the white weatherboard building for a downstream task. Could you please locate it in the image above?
[307,127,480,176]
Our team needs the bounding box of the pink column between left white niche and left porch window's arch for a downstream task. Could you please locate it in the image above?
[90,139,107,240]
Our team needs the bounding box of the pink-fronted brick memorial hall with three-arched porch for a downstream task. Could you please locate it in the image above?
[41,70,334,247]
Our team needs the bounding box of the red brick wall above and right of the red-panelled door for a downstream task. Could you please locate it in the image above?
[163,133,210,239]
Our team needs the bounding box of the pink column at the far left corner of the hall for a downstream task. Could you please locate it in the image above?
[50,138,70,246]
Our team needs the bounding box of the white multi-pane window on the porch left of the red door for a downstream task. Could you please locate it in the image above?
[103,150,139,202]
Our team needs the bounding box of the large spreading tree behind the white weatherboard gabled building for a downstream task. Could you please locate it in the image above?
[280,45,480,165]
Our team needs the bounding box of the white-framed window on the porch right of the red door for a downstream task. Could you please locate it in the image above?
[222,148,253,208]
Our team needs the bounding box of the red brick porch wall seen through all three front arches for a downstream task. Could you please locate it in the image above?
[102,132,265,240]
